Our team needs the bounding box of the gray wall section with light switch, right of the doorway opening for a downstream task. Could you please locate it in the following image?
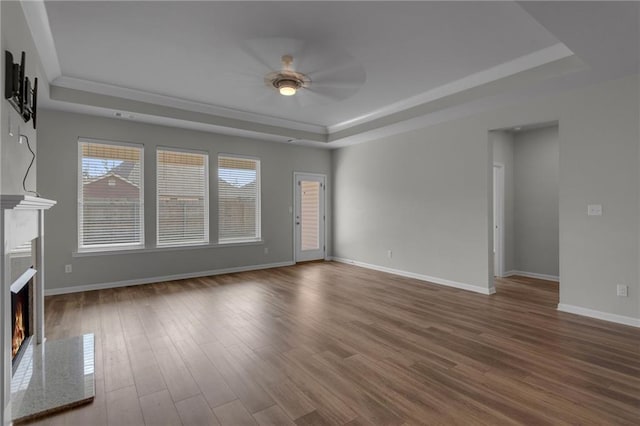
[559,75,640,318]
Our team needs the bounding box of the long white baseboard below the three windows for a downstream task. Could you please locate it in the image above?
[44,262,295,296]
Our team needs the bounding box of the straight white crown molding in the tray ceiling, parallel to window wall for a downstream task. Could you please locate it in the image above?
[51,75,327,135]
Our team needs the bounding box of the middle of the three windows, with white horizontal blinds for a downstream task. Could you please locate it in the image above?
[157,150,209,246]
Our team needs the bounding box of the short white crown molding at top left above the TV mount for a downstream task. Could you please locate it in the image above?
[20,0,62,83]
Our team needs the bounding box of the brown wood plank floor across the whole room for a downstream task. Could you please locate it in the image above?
[25,262,640,426]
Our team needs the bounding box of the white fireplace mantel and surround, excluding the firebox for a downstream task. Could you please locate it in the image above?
[0,194,56,425]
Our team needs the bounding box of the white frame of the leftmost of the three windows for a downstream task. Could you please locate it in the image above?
[76,138,145,253]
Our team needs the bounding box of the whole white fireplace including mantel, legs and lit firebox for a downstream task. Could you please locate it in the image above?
[0,194,57,426]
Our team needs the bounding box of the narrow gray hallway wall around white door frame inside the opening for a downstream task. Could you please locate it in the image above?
[489,130,517,272]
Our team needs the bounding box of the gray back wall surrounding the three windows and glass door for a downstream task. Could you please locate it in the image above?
[38,110,331,292]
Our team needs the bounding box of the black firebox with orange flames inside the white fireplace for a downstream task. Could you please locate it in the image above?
[11,278,33,370]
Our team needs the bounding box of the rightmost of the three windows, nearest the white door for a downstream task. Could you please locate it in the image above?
[218,156,261,243]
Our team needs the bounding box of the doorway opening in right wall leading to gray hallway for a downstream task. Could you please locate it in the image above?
[489,122,560,300]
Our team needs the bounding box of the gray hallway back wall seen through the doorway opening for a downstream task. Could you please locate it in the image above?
[507,126,560,277]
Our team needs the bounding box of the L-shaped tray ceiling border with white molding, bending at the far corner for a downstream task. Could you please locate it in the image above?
[43,47,589,148]
